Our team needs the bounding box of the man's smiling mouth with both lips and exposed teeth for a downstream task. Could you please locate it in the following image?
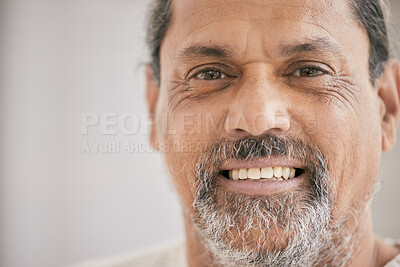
[218,159,306,195]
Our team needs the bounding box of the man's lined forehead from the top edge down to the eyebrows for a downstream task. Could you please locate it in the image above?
[161,0,368,68]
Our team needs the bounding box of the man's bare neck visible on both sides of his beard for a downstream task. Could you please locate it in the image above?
[184,210,400,267]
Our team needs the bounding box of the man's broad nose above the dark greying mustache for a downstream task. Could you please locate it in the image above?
[224,75,290,138]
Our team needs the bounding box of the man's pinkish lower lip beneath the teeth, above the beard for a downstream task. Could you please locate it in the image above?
[217,173,304,195]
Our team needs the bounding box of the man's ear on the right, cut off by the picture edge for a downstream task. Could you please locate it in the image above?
[377,59,400,151]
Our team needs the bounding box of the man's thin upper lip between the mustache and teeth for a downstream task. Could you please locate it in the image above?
[221,157,304,170]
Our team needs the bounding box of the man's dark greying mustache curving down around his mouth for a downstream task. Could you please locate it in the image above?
[195,134,334,203]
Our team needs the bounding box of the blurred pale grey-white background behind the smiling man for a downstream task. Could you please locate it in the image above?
[0,0,400,267]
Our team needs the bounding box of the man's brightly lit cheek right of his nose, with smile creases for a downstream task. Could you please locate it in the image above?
[314,88,381,220]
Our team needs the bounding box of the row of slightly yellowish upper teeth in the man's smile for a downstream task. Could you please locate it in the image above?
[229,167,296,181]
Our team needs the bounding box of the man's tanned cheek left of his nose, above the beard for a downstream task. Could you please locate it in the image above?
[161,102,224,209]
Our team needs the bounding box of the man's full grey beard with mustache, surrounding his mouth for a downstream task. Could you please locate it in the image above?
[192,135,356,266]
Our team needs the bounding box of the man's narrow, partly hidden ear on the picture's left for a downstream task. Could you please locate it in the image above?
[146,65,160,150]
